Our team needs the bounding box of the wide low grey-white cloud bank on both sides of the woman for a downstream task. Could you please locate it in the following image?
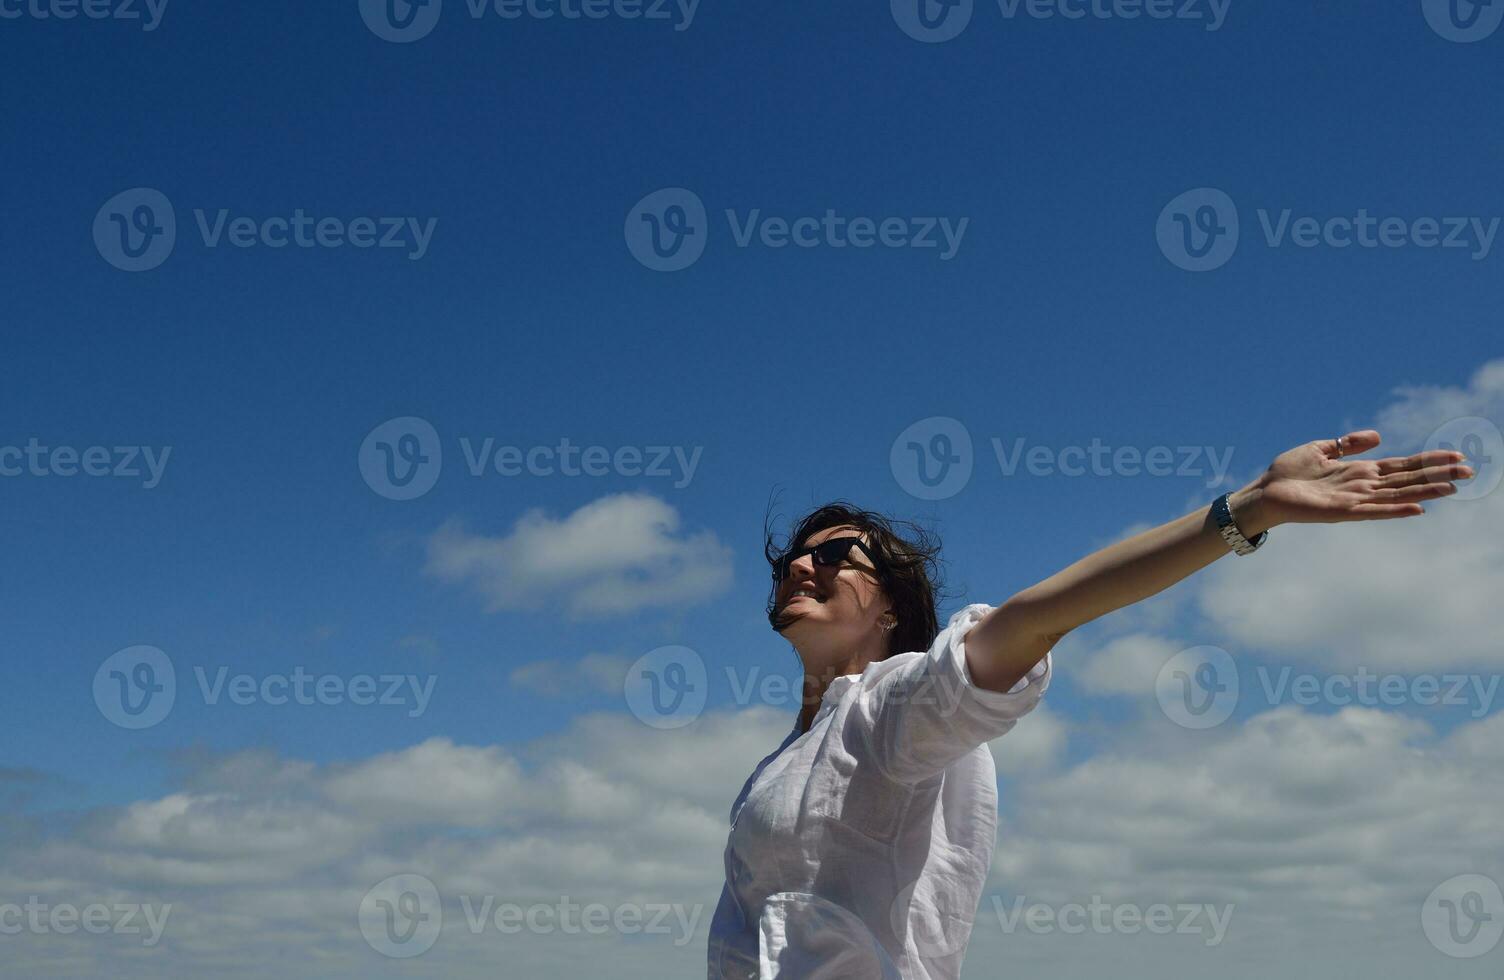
[11,705,1504,980]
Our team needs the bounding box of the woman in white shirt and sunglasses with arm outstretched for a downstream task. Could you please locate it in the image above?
[708,430,1472,980]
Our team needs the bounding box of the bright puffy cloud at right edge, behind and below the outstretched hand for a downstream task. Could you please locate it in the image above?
[1197,361,1504,673]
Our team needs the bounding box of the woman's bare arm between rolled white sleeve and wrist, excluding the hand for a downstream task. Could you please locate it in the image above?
[966,481,1271,690]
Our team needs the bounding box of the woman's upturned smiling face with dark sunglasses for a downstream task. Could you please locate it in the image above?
[776,526,892,667]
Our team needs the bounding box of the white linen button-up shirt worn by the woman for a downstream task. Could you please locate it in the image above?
[708,603,1051,980]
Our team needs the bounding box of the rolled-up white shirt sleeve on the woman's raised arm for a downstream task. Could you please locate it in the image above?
[851,603,1053,783]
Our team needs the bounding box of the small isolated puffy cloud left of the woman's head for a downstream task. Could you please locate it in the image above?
[424,493,731,616]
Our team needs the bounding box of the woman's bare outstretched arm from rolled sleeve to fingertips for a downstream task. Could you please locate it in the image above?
[966,428,1472,691]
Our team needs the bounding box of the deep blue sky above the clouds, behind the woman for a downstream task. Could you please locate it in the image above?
[0,0,1504,975]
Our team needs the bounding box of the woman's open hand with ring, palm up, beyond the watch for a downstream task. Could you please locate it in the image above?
[1259,428,1474,525]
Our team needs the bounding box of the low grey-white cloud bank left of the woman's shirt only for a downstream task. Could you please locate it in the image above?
[0,708,790,980]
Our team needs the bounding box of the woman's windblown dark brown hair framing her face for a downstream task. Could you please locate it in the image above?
[763,501,940,657]
